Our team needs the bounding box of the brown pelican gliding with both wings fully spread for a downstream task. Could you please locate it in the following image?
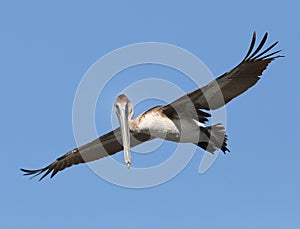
[21,32,283,180]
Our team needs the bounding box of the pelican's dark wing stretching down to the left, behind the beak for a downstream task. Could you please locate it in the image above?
[21,128,153,180]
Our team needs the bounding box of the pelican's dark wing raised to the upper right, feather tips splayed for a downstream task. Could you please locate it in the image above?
[164,32,282,114]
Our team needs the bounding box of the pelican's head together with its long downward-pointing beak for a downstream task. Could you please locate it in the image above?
[115,94,133,168]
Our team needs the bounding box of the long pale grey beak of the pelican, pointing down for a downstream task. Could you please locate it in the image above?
[117,106,131,169]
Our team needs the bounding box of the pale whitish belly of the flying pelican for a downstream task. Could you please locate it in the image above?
[139,112,205,143]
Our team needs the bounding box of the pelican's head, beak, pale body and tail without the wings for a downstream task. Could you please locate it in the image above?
[115,94,229,168]
